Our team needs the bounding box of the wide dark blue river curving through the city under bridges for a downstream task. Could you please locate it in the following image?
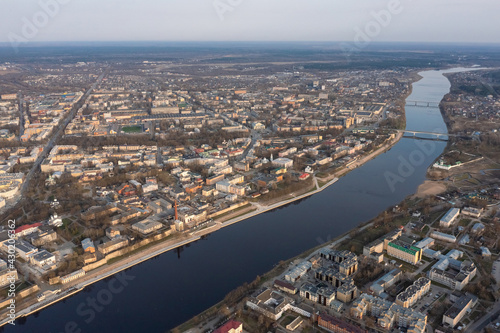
[4,69,472,333]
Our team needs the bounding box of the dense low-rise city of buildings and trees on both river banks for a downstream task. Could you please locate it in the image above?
[0,47,500,333]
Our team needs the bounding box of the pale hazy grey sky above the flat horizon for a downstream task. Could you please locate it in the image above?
[0,0,500,43]
